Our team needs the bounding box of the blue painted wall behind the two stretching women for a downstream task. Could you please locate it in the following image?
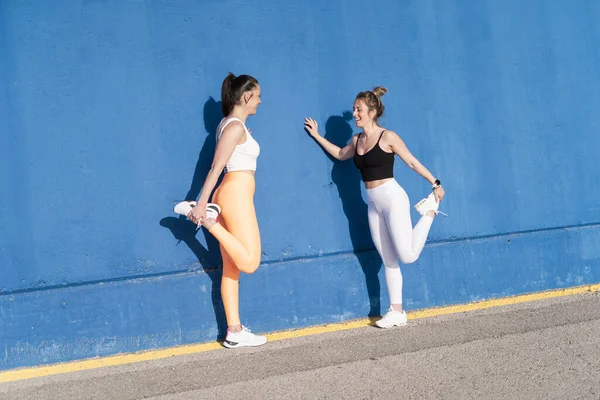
[0,0,600,369]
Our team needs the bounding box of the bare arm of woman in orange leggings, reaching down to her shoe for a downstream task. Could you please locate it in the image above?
[189,122,246,222]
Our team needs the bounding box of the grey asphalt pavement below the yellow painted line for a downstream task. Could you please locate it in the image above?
[0,293,600,400]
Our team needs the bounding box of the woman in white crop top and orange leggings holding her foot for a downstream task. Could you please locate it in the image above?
[175,73,267,348]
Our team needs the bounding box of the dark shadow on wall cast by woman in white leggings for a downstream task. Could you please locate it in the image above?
[325,111,381,317]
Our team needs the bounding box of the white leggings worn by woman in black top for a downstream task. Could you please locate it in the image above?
[367,179,433,304]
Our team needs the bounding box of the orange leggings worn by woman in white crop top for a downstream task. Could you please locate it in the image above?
[210,171,261,326]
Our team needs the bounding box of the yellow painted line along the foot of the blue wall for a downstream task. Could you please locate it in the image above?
[0,284,600,383]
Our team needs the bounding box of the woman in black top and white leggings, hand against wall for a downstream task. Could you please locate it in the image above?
[304,86,444,328]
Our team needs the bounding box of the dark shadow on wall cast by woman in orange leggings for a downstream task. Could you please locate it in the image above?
[160,97,227,340]
